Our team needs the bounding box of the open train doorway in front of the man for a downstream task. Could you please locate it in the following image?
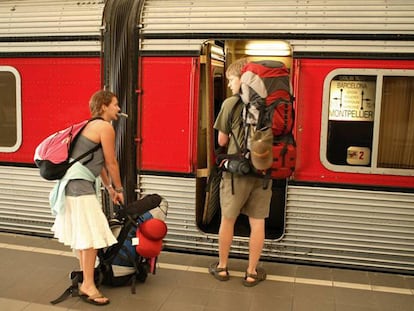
[196,40,292,239]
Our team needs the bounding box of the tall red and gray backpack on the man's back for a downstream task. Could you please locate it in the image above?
[240,60,296,179]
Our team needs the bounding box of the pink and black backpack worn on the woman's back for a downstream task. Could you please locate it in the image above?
[34,117,102,180]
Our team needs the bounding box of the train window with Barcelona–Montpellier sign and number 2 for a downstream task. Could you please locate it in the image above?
[321,69,414,175]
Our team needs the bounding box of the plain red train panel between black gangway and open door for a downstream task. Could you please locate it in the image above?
[137,57,199,173]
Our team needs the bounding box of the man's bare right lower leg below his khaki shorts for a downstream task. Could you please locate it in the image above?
[247,217,265,282]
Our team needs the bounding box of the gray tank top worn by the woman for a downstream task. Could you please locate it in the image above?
[66,134,104,196]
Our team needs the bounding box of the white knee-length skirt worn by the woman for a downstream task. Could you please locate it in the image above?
[52,194,117,250]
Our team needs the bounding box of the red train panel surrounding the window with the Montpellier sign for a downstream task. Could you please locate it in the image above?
[294,59,414,187]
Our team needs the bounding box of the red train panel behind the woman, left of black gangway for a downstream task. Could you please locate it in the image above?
[0,57,101,164]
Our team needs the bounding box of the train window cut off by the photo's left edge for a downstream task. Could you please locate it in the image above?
[0,66,22,152]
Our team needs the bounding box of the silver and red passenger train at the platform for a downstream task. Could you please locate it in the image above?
[0,0,414,274]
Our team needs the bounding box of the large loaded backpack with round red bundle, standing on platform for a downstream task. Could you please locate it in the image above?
[50,194,168,305]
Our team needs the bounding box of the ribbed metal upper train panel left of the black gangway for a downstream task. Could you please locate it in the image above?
[0,0,104,53]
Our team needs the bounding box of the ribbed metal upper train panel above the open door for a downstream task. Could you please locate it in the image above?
[139,0,414,53]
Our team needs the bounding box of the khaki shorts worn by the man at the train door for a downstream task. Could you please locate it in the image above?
[220,172,272,219]
